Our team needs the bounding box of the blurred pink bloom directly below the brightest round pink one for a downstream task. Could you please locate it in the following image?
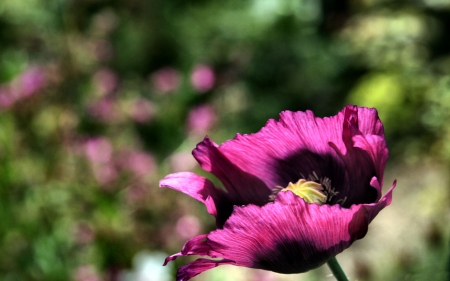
[187,105,217,135]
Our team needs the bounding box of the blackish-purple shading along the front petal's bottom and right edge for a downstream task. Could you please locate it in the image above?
[252,208,368,274]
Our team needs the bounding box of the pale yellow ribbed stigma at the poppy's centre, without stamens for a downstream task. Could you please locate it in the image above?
[281,179,327,205]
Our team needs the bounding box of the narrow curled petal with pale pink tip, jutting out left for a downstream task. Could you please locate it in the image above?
[159,172,233,228]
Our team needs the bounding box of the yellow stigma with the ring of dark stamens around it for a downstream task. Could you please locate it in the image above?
[269,172,346,205]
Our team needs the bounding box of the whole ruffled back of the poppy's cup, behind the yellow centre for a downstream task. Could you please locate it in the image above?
[193,106,387,207]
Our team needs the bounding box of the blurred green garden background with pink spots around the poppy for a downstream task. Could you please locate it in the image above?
[0,0,450,281]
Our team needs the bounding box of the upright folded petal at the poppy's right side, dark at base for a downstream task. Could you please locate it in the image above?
[330,106,388,207]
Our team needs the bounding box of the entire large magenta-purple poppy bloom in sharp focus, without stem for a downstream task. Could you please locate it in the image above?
[160,105,395,281]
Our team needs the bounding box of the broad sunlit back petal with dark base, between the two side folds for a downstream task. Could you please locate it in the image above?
[212,111,345,192]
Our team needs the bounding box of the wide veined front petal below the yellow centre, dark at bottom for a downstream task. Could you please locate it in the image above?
[207,192,368,273]
